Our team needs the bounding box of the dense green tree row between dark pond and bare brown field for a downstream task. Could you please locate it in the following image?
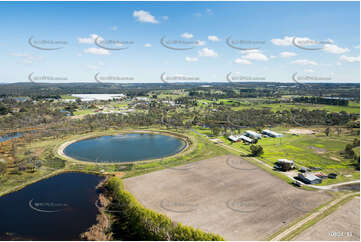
[105,177,224,241]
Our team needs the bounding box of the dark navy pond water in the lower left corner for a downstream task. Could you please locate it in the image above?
[0,173,103,240]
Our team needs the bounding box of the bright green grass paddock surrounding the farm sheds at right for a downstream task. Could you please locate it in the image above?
[195,127,360,185]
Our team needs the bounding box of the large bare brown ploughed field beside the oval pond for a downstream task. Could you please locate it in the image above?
[124,156,331,240]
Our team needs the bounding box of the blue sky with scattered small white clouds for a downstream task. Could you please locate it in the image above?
[0,2,360,83]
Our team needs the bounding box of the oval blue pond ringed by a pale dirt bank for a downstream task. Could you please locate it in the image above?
[64,134,185,162]
